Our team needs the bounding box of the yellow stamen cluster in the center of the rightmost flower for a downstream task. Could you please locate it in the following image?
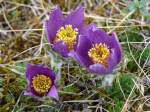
[88,43,110,67]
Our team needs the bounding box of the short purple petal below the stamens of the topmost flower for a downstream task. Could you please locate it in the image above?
[53,41,69,57]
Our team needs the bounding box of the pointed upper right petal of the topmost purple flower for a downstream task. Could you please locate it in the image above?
[65,7,84,29]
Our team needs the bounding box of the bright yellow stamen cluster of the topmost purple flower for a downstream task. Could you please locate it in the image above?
[55,25,78,51]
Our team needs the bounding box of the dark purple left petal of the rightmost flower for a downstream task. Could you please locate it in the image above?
[74,36,92,67]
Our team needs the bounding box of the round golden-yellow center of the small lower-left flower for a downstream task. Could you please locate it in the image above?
[32,75,52,94]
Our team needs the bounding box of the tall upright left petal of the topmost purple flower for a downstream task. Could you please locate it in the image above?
[46,7,64,43]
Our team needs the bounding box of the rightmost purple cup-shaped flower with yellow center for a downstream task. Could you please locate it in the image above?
[73,26,122,75]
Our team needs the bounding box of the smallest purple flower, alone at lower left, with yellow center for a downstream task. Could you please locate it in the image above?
[24,64,58,99]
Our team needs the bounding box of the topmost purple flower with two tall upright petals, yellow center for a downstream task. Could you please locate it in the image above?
[45,7,84,57]
